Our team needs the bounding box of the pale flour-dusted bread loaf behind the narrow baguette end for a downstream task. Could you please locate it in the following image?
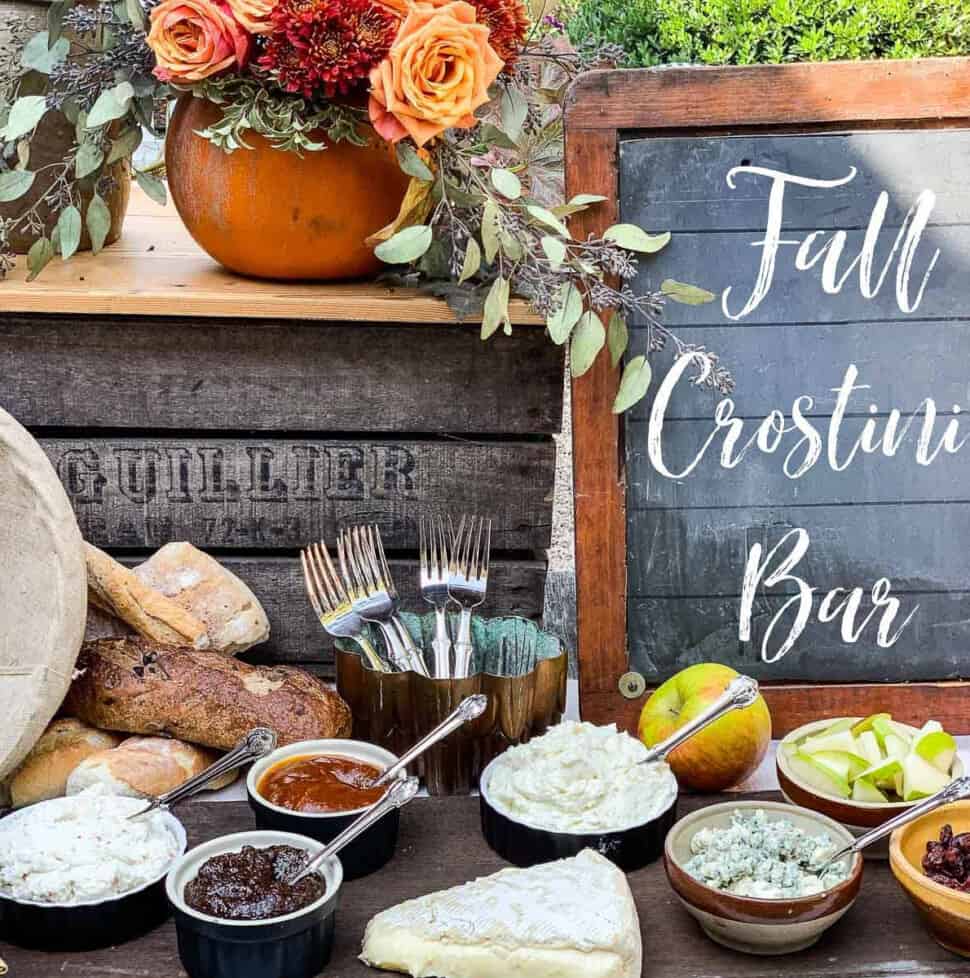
[134,543,269,655]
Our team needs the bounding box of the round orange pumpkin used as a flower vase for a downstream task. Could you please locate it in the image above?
[165,96,408,281]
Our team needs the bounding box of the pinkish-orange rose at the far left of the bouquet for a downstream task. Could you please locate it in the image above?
[148,0,252,82]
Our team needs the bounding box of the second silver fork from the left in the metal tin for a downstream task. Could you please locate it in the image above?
[337,526,428,676]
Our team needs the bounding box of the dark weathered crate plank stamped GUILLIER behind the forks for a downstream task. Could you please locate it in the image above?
[41,438,555,552]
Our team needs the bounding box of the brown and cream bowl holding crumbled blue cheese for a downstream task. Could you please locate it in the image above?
[664,801,863,955]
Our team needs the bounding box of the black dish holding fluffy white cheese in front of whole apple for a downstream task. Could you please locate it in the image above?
[479,757,677,873]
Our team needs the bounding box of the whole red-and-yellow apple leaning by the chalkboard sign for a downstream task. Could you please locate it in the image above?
[637,662,771,791]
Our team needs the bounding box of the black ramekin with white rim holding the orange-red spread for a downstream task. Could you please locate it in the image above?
[246,740,401,880]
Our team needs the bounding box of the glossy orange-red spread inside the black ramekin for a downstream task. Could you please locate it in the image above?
[257,754,387,815]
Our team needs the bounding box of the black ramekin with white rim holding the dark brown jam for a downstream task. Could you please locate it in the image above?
[165,832,343,978]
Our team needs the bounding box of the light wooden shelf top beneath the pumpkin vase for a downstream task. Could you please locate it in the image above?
[0,187,540,324]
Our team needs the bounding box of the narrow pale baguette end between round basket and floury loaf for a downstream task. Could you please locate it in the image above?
[84,543,209,649]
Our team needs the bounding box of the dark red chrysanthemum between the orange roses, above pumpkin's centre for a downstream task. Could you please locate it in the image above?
[259,0,400,98]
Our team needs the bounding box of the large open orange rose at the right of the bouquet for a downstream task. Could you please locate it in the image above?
[369,0,503,146]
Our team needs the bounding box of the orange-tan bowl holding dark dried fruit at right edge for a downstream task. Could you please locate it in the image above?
[889,801,970,958]
